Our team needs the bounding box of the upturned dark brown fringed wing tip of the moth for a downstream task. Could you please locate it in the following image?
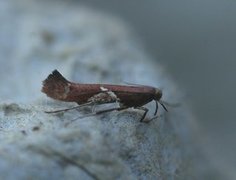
[41,70,69,99]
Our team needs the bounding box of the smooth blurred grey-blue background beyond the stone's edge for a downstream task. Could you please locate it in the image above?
[74,0,236,179]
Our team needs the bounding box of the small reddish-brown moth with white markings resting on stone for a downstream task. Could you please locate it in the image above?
[42,70,167,122]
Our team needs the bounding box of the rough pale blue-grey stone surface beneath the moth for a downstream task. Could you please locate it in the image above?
[0,1,208,179]
